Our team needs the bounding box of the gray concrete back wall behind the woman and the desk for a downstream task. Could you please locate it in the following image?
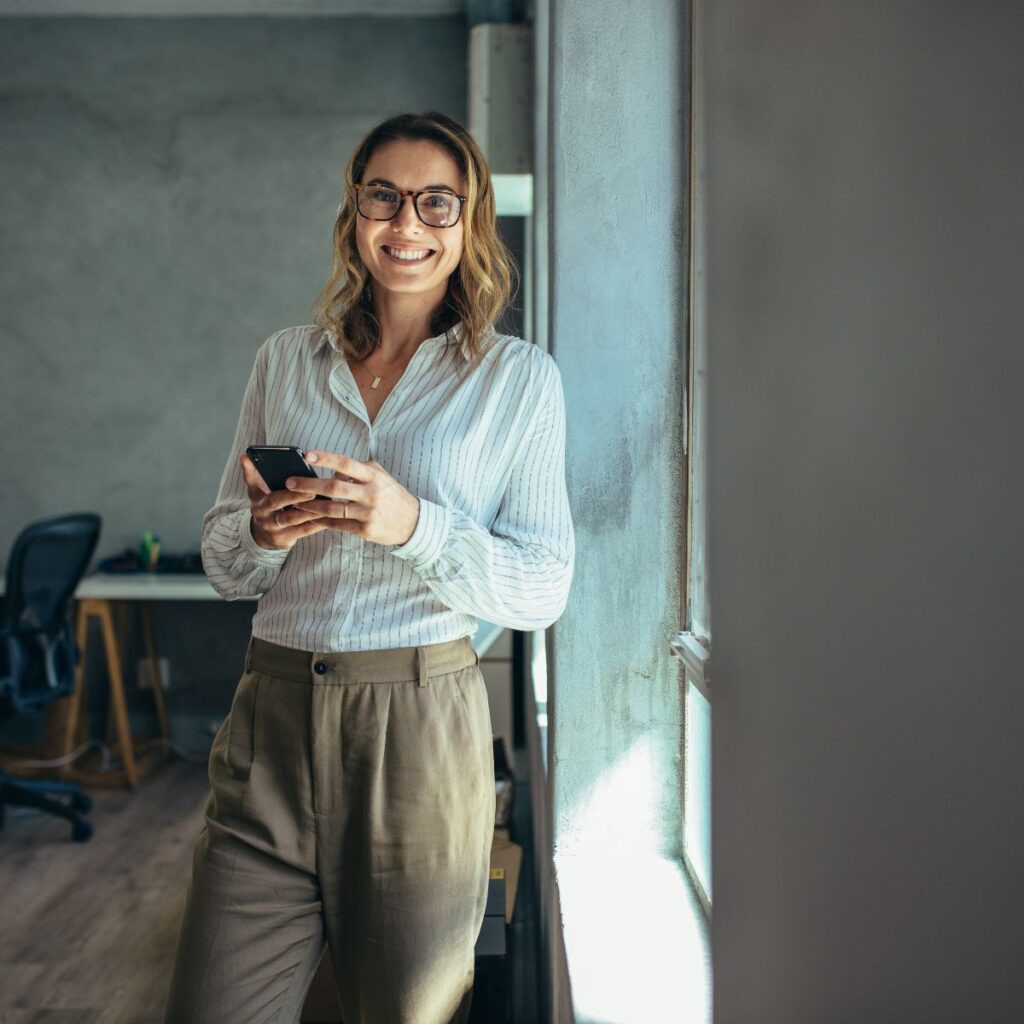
[0,17,466,737]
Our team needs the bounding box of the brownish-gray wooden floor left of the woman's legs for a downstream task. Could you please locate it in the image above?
[0,759,208,1024]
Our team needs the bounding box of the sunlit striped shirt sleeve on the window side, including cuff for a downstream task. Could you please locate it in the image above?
[391,358,575,630]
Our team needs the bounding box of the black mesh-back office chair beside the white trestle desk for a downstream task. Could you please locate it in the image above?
[0,512,100,842]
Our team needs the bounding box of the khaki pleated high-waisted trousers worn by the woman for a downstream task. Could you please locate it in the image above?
[165,637,495,1024]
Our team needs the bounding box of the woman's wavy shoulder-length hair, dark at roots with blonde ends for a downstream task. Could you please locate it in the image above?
[313,111,520,366]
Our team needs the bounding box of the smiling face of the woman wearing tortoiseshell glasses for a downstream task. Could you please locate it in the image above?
[355,139,466,302]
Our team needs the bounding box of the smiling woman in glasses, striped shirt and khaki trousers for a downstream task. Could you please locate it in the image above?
[166,113,575,1024]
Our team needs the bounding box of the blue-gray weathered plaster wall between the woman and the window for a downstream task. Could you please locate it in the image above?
[547,0,686,860]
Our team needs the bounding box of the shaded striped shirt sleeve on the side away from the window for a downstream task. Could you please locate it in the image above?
[200,339,289,601]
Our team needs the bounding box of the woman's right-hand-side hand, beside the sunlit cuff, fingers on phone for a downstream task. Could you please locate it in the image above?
[287,452,420,544]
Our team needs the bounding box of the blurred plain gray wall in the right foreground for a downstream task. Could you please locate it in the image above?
[708,0,1024,1024]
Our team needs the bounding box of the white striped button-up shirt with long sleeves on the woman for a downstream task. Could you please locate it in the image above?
[202,325,575,652]
